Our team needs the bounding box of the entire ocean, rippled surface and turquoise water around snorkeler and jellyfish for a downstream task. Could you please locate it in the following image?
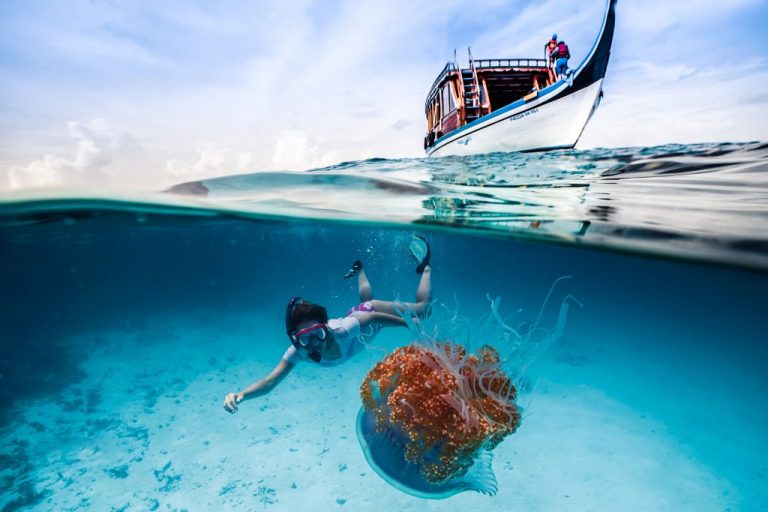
[0,143,768,512]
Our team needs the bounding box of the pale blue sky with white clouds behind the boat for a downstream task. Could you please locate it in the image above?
[0,0,768,191]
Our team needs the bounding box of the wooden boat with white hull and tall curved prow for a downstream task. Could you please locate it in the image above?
[424,0,617,156]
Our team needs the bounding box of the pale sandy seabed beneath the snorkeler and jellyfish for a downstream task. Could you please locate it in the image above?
[0,317,768,512]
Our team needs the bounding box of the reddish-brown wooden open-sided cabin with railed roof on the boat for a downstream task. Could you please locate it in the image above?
[424,50,556,149]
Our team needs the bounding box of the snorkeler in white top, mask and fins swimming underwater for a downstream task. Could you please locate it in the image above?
[224,235,432,413]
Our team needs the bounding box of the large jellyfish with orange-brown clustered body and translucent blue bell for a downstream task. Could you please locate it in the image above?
[357,278,580,499]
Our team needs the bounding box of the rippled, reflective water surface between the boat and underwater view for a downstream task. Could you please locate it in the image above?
[3,143,768,270]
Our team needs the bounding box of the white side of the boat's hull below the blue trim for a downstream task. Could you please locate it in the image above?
[429,79,603,156]
